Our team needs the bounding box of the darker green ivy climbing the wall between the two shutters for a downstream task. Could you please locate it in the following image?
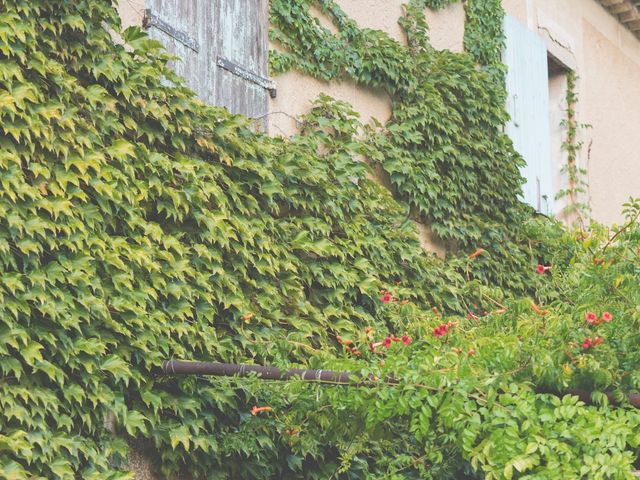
[271,0,544,291]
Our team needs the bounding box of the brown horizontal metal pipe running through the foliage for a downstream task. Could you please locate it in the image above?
[162,360,640,408]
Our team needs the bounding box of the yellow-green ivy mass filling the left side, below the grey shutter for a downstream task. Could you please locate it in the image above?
[0,0,476,479]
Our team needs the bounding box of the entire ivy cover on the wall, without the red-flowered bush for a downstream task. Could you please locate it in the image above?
[0,0,588,479]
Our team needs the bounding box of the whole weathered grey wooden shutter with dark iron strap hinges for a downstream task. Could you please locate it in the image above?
[144,0,275,124]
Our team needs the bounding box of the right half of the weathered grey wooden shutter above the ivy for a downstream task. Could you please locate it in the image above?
[214,0,269,127]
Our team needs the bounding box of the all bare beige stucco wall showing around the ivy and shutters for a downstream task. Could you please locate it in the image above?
[119,0,640,227]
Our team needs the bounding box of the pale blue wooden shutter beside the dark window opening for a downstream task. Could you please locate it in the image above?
[504,16,554,214]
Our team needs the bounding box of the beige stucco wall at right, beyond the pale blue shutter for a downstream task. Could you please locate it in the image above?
[503,0,640,223]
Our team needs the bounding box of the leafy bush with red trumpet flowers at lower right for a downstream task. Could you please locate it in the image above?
[249,202,640,479]
